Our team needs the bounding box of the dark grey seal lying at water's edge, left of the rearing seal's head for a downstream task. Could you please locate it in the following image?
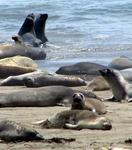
[56,62,106,75]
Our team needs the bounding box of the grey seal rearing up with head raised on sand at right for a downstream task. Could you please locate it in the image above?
[100,69,132,102]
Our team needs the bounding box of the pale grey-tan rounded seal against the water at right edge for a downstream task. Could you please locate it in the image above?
[109,56,132,70]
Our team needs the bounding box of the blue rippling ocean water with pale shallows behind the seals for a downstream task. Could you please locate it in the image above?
[0,0,132,72]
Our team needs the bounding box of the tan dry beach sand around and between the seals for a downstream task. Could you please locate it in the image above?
[0,87,132,150]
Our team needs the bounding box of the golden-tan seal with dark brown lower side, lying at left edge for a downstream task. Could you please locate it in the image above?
[0,56,37,78]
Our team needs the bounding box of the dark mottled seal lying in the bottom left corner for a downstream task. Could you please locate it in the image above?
[0,120,43,142]
